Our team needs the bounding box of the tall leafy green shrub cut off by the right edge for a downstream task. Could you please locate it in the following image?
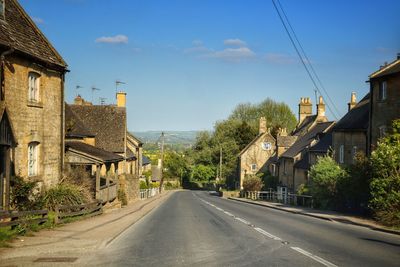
[370,119,400,226]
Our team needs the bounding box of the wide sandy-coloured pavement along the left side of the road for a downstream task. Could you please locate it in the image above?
[0,191,173,266]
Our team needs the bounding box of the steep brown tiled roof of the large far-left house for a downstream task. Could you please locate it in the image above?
[0,0,67,69]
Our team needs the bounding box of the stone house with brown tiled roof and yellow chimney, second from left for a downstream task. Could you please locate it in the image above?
[69,92,141,199]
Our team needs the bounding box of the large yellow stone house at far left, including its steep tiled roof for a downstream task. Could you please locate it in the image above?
[0,0,67,208]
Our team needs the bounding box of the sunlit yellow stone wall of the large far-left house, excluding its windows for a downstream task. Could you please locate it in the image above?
[5,55,64,187]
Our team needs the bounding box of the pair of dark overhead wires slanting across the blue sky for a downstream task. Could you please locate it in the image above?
[272,0,338,119]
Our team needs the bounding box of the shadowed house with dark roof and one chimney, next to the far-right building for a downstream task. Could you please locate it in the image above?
[332,93,370,165]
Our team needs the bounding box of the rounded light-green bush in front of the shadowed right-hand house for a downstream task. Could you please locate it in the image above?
[309,155,348,209]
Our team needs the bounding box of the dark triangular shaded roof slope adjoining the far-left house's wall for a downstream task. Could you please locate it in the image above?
[65,103,95,137]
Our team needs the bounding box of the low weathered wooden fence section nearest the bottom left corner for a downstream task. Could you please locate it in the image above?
[0,210,48,227]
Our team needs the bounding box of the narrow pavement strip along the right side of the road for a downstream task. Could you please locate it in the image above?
[228,197,400,235]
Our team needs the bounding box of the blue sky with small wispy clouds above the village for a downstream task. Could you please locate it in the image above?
[19,0,400,131]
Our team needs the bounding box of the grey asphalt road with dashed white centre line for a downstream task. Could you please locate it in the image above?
[87,191,400,266]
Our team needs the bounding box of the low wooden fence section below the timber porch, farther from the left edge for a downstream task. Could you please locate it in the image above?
[55,201,103,223]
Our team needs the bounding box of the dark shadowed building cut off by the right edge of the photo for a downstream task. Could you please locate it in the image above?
[369,54,400,152]
